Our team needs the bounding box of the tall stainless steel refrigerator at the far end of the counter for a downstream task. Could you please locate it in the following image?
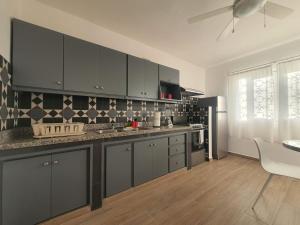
[198,96,228,159]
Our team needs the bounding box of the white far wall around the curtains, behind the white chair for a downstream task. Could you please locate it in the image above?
[206,40,300,158]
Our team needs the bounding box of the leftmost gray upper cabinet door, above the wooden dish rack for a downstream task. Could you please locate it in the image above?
[12,19,63,90]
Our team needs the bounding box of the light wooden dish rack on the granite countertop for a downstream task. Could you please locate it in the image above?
[32,123,85,138]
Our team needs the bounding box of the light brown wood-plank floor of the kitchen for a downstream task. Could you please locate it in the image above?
[44,156,300,225]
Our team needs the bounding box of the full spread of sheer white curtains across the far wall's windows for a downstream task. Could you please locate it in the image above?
[228,60,300,142]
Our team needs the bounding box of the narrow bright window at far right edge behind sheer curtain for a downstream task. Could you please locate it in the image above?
[287,71,300,119]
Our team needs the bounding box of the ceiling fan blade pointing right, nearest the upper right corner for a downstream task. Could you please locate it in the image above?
[259,1,294,19]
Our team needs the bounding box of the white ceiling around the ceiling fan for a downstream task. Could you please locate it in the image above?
[39,0,300,68]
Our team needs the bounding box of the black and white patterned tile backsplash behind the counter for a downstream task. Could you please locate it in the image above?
[0,55,200,130]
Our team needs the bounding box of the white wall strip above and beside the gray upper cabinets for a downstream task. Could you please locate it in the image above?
[0,0,205,91]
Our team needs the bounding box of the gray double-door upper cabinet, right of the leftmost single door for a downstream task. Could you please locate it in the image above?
[64,35,127,96]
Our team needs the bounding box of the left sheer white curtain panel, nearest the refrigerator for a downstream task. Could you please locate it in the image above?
[228,66,278,142]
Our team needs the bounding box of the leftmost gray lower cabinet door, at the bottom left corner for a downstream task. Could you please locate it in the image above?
[2,156,51,225]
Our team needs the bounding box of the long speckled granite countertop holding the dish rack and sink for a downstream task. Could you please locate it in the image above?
[0,126,192,152]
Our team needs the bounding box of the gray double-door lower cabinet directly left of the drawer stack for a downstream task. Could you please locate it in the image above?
[134,138,168,185]
